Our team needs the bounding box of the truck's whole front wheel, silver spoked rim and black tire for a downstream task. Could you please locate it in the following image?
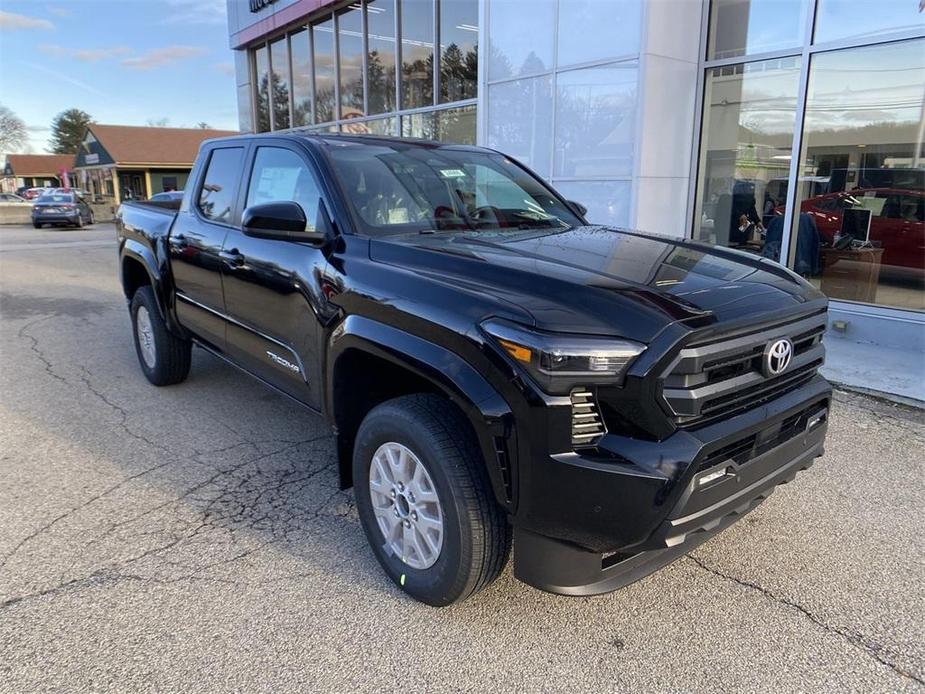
[353,394,511,607]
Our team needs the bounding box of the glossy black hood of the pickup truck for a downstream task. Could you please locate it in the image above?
[370,226,822,341]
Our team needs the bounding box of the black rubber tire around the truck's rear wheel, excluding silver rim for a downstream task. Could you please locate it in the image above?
[131,286,192,386]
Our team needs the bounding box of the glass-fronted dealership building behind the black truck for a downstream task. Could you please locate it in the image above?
[228,0,925,400]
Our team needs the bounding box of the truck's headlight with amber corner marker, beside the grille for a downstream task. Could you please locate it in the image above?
[482,318,645,393]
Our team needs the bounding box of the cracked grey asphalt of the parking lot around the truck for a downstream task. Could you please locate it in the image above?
[0,224,925,692]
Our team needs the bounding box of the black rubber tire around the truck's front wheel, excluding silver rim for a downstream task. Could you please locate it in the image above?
[353,394,511,607]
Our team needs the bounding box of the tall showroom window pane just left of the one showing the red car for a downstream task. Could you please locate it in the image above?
[694,58,800,253]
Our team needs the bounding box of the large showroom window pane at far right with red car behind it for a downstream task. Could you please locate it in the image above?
[788,40,925,310]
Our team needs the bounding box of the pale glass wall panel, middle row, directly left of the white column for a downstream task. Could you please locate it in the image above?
[554,61,638,178]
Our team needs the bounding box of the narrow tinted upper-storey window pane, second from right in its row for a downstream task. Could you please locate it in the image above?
[401,0,434,108]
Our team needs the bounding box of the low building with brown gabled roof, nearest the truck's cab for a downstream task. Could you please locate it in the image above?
[72,123,238,205]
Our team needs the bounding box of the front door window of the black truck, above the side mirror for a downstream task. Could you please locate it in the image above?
[247,147,321,231]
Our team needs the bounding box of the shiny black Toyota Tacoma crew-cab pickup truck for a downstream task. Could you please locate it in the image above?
[118,132,831,605]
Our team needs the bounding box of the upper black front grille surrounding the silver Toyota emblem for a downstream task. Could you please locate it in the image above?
[662,312,826,426]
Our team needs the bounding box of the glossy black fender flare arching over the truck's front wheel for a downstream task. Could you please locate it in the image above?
[325,315,515,508]
